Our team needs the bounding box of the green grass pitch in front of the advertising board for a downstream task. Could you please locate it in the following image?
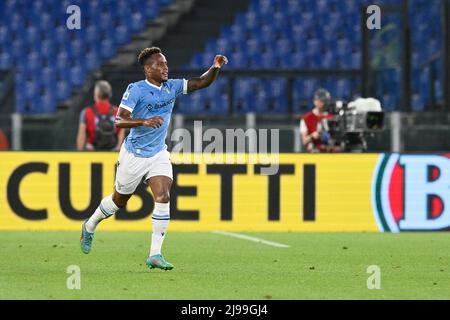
[0,231,450,300]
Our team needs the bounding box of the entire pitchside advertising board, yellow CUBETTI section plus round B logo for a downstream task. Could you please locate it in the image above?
[0,152,450,232]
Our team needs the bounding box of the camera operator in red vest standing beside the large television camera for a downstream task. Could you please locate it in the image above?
[300,89,337,153]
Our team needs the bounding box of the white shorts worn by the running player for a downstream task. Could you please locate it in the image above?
[114,143,173,195]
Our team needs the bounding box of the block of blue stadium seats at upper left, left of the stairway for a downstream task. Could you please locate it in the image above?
[0,0,173,114]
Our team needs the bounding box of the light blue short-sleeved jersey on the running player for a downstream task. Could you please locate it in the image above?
[120,79,187,158]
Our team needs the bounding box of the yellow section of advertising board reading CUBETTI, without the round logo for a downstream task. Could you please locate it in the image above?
[0,152,379,232]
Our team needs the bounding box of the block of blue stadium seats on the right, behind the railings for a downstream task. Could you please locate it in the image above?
[178,0,443,113]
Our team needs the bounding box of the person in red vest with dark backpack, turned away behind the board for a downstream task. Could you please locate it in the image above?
[77,80,125,151]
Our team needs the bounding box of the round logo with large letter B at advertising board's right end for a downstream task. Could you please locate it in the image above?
[372,154,450,232]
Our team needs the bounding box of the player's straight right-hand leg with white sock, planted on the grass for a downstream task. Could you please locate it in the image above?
[147,176,173,270]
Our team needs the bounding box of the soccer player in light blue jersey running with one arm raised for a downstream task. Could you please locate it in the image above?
[80,47,228,270]
